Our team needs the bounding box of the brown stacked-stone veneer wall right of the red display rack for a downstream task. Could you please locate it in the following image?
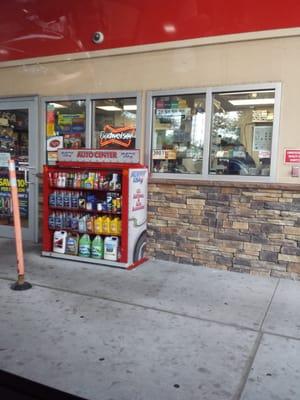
[147,180,300,280]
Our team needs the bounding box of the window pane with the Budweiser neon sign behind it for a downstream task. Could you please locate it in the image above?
[92,97,137,149]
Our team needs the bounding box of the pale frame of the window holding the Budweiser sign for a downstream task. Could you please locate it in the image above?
[40,91,142,164]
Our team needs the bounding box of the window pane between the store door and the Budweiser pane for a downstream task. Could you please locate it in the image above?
[46,100,86,164]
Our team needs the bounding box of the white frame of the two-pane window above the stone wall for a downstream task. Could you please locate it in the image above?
[145,82,281,183]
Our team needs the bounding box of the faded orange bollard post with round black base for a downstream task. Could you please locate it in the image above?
[8,159,32,290]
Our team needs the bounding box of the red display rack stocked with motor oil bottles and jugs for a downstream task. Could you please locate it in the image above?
[42,150,148,269]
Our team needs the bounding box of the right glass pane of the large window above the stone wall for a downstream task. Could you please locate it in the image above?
[209,90,275,176]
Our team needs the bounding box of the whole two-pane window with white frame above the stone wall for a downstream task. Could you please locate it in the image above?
[146,83,280,182]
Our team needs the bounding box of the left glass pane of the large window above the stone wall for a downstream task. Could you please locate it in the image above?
[151,94,205,174]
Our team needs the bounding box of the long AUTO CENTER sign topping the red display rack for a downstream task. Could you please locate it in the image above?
[58,149,140,164]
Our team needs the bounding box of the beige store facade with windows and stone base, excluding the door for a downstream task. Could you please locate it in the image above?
[0,24,300,278]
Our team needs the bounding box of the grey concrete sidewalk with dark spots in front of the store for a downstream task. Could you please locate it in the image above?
[0,239,300,400]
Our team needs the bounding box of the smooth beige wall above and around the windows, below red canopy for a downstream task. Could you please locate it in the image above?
[0,36,300,183]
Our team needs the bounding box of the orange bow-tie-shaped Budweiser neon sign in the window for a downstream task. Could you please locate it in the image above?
[99,125,135,148]
